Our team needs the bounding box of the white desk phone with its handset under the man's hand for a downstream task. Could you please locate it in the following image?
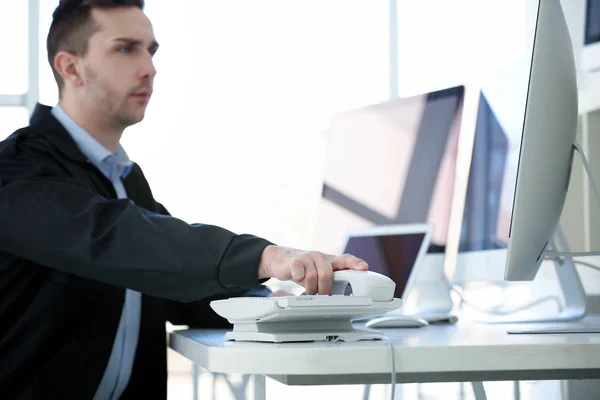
[210,270,402,342]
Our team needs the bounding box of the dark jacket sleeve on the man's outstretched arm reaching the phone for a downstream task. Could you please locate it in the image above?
[0,150,271,302]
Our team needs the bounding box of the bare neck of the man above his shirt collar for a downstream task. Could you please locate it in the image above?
[59,99,123,153]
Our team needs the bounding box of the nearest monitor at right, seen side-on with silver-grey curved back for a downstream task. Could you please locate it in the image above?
[505,0,578,281]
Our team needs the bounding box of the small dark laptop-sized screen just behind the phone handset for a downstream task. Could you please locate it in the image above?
[345,232,425,299]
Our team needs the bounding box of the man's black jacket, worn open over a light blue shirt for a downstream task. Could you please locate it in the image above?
[0,105,271,399]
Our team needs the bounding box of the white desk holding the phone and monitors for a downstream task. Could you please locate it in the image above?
[169,317,600,398]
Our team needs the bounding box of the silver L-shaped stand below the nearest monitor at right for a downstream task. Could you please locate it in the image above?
[475,226,600,334]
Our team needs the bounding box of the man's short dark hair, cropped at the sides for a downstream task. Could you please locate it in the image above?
[46,0,144,93]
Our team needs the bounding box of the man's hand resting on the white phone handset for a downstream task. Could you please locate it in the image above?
[258,245,369,294]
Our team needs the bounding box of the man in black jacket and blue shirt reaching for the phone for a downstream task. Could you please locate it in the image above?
[0,0,367,399]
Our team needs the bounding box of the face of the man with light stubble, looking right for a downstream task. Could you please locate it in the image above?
[79,7,158,128]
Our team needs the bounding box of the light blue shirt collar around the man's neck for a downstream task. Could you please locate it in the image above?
[51,104,133,180]
